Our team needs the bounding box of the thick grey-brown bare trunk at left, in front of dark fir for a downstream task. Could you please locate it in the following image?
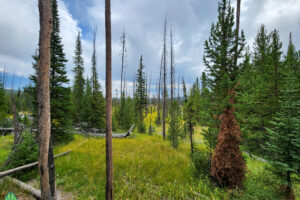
[37,0,56,200]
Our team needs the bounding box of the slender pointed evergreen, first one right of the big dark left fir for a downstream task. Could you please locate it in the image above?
[73,32,85,123]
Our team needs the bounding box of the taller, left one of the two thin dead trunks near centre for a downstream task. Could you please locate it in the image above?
[163,18,167,140]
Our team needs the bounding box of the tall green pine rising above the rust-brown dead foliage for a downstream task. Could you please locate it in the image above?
[203,0,245,151]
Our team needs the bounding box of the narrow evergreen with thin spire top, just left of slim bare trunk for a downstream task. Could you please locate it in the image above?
[90,30,105,129]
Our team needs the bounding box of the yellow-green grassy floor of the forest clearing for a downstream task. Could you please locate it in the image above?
[0,127,300,200]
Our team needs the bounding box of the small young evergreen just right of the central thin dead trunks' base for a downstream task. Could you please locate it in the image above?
[167,100,183,148]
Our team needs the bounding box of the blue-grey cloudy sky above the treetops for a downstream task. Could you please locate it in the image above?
[0,0,300,96]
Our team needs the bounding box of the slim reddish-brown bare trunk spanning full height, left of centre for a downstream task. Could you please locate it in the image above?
[105,0,113,200]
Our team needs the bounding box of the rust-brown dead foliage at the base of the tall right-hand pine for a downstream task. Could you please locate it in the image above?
[211,88,246,188]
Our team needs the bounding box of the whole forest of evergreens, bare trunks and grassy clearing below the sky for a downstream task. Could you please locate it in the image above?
[0,0,300,200]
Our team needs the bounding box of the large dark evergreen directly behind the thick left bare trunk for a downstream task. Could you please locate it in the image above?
[26,0,72,142]
